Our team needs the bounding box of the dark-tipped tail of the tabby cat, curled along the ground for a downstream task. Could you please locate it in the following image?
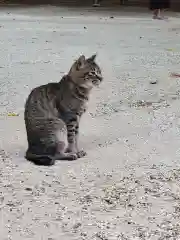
[25,151,55,166]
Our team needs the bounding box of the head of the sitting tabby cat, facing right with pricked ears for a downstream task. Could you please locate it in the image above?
[68,54,103,89]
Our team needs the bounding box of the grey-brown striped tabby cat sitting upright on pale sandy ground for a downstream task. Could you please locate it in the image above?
[24,55,103,166]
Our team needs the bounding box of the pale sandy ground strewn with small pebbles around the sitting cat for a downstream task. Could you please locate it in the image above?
[0,6,180,240]
